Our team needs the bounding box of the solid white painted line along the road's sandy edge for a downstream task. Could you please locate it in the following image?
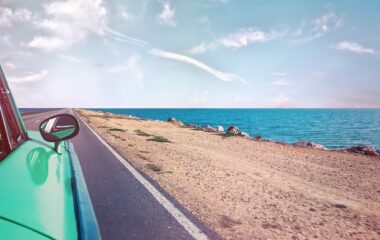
[75,113,208,240]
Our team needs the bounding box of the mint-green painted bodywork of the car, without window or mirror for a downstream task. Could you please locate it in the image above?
[0,132,78,239]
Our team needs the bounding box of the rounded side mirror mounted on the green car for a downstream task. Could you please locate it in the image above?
[40,114,79,142]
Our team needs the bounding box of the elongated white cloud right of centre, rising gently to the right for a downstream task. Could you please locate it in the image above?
[189,28,286,54]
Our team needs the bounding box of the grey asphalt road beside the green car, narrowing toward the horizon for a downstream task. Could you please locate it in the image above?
[23,109,220,240]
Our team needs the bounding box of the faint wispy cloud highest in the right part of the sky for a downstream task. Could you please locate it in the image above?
[292,12,343,43]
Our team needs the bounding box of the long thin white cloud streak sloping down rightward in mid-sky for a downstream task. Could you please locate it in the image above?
[150,49,246,83]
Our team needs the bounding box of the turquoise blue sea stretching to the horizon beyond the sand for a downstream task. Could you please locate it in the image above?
[87,108,380,149]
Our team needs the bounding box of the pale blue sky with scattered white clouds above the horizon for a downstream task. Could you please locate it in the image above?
[0,0,380,108]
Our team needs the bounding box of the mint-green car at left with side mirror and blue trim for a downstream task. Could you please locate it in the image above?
[0,67,100,240]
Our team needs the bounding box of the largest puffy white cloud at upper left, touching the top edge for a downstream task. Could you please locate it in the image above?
[27,0,107,51]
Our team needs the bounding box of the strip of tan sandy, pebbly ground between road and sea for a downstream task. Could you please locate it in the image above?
[77,110,380,239]
